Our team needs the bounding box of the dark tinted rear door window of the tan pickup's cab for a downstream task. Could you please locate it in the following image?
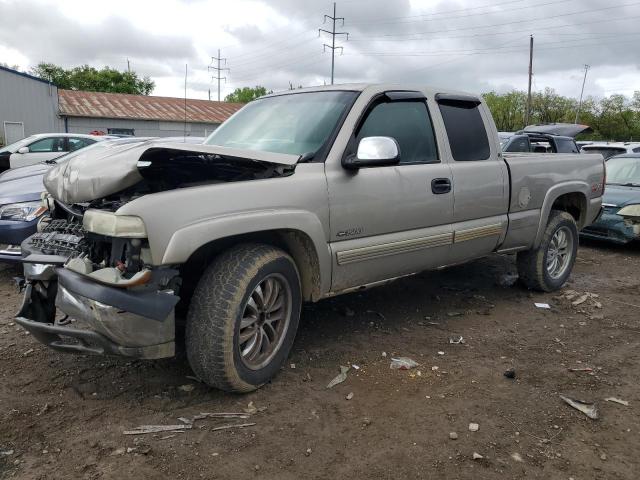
[438,98,491,162]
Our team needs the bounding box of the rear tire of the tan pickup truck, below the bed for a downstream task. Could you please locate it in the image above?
[517,210,578,292]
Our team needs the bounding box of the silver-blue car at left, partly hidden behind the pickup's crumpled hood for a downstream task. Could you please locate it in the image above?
[0,137,204,262]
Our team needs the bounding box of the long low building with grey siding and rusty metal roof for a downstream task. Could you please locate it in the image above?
[0,66,243,145]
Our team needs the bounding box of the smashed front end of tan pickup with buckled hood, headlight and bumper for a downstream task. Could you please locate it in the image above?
[16,143,297,358]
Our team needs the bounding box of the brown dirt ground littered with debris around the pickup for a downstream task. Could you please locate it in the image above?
[0,244,640,480]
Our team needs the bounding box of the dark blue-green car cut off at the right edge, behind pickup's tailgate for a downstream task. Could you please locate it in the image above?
[581,153,640,244]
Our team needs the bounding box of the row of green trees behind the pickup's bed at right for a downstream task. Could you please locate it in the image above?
[483,87,640,141]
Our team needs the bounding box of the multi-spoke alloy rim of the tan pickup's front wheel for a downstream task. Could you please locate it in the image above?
[238,273,292,370]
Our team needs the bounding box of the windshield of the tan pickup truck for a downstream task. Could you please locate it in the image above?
[205,91,357,155]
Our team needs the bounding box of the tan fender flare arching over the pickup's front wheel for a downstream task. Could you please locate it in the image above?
[161,209,331,293]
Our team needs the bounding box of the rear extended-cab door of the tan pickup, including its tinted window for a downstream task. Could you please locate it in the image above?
[436,94,509,264]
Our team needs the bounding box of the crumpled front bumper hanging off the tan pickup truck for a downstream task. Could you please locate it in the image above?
[16,264,180,359]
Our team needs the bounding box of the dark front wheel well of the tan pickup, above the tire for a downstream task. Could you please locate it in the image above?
[180,230,321,307]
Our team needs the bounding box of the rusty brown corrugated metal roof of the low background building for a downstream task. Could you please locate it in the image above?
[58,90,244,123]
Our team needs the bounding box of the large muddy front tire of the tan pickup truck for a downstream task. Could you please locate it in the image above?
[185,244,302,392]
